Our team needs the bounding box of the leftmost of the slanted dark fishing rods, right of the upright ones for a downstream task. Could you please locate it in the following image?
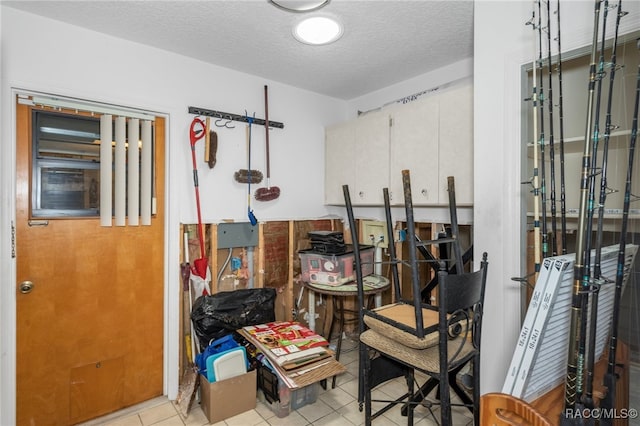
[561,0,601,418]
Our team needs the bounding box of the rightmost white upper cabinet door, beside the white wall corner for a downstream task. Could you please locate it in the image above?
[438,84,473,206]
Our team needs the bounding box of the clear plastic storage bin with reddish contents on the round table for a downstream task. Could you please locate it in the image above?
[298,245,374,286]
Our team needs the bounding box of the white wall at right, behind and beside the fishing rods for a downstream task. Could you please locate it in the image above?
[474,0,640,393]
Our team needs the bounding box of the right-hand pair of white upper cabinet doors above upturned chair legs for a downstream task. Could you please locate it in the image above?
[390,85,473,205]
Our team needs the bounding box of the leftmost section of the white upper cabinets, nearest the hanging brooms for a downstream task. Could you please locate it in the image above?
[325,111,389,205]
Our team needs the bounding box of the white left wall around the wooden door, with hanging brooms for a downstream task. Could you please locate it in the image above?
[0,5,346,424]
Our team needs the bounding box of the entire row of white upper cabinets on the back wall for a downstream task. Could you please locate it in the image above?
[325,84,473,206]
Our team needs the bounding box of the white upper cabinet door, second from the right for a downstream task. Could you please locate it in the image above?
[389,96,446,205]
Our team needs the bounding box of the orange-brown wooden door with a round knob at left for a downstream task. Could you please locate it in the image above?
[16,100,165,426]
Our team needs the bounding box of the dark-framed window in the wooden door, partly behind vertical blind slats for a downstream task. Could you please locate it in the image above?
[31,108,153,223]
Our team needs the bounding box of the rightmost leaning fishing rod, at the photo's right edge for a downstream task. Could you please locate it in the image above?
[600,37,640,425]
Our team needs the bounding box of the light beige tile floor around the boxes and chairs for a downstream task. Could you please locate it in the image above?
[82,339,473,426]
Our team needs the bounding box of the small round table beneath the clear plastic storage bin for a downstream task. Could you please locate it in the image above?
[302,275,390,388]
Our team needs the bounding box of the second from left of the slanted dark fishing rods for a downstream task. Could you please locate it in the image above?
[577,0,609,408]
